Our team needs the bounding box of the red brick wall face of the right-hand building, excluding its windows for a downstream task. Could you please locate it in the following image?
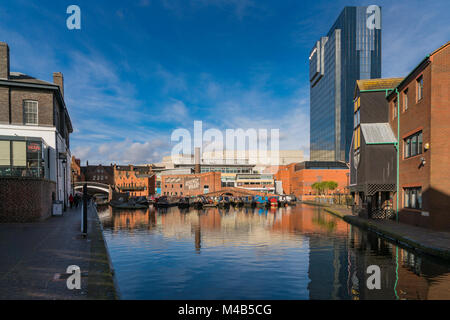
[389,45,450,230]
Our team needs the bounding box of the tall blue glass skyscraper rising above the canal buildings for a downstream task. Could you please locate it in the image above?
[309,6,381,162]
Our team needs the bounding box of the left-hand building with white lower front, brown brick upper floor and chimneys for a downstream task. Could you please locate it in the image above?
[0,42,73,212]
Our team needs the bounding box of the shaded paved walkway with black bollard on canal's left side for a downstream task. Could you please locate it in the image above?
[0,206,116,300]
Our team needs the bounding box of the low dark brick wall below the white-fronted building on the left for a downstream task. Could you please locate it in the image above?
[0,177,56,222]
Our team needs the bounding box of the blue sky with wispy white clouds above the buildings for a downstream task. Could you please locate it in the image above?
[0,0,450,163]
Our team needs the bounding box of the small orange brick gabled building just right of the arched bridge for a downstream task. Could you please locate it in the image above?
[113,165,156,197]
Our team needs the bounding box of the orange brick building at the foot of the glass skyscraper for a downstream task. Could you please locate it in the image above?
[275,161,349,200]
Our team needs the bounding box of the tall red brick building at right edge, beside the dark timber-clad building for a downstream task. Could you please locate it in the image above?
[387,42,450,230]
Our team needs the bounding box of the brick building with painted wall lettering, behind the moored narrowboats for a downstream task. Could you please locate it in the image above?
[161,172,221,196]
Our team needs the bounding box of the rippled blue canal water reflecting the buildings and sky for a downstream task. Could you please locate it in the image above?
[99,205,450,299]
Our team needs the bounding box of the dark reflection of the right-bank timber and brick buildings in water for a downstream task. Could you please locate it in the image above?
[349,228,450,300]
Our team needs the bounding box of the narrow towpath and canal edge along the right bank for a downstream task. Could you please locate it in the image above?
[302,201,450,261]
